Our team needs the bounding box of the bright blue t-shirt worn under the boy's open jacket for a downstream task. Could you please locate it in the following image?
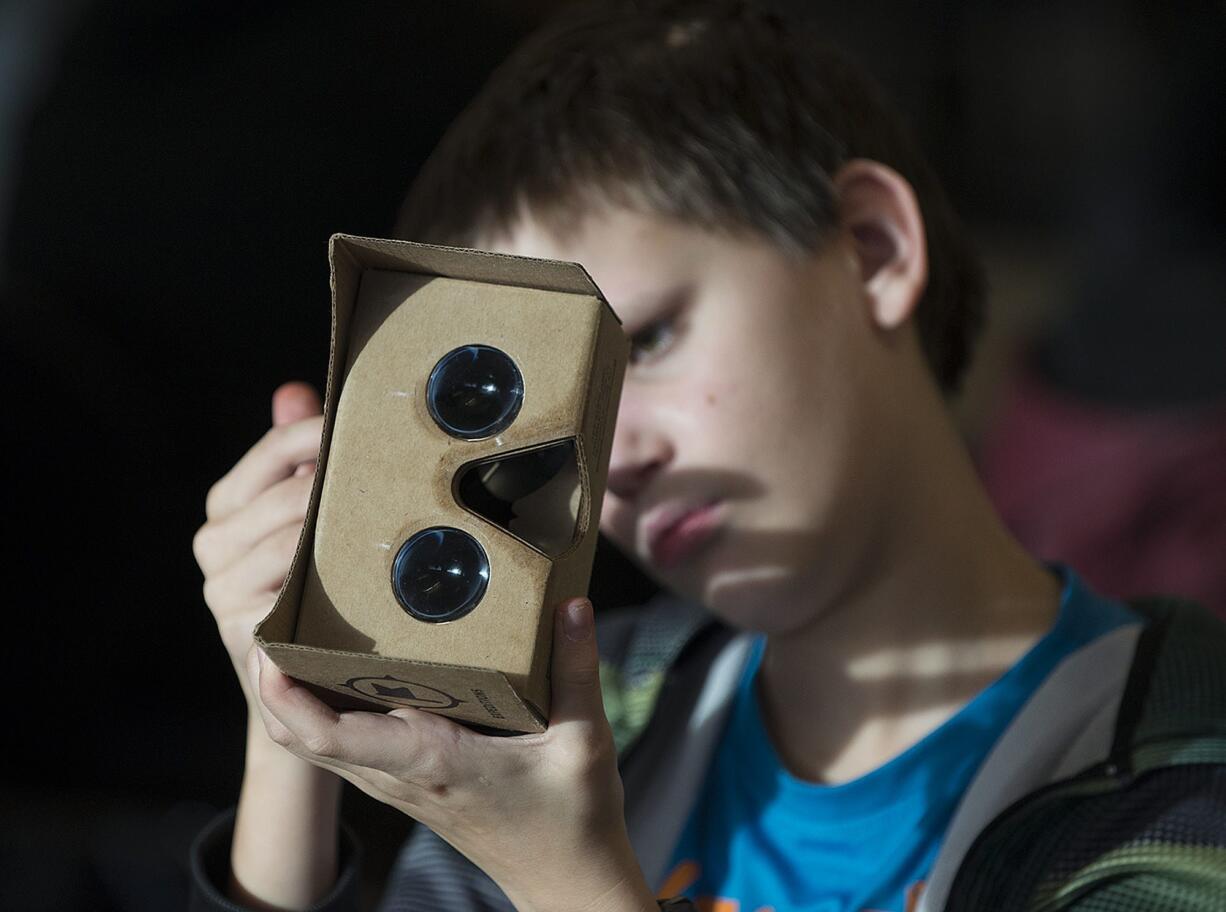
[662,566,1138,912]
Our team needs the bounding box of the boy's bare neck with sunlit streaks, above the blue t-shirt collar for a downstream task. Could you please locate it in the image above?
[758,387,1060,783]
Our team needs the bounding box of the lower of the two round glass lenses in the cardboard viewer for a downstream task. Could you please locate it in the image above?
[391,526,489,621]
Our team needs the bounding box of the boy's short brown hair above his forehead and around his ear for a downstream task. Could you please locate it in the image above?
[396,0,984,392]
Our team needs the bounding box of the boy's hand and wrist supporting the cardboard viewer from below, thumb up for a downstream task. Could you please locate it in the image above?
[248,599,657,912]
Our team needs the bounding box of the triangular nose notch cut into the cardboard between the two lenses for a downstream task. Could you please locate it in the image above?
[452,438,587,558]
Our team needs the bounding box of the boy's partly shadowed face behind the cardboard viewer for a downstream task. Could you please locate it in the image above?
[479,210,897,633]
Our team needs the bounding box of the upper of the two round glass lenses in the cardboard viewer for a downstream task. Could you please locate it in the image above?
[425,346,524,440]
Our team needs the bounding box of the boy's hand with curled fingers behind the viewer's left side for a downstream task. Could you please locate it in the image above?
[191,382,324,717]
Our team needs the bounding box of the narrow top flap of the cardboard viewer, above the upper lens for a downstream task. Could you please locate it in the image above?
[329,234,613,304]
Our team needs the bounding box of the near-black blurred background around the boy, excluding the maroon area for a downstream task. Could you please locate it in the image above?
[0,0,1226,910]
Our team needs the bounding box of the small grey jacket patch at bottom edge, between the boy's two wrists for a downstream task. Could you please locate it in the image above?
[372,825,515,912]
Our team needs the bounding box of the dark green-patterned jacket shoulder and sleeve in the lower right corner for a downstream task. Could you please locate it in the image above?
[926,598,1226,912]
